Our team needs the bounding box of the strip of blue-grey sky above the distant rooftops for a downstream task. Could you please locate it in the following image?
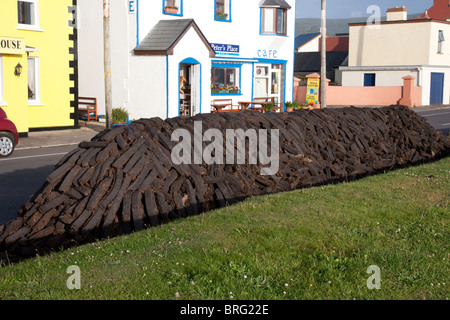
[296,0,433,19]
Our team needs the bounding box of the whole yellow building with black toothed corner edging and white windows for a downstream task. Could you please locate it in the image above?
[0,0,78,136]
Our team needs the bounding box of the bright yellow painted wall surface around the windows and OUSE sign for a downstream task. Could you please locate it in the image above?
[0,0,74,132]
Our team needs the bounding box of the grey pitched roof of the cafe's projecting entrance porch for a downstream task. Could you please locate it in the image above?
[134,19,214,52]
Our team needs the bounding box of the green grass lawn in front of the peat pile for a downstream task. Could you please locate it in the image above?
[0,157,450,300]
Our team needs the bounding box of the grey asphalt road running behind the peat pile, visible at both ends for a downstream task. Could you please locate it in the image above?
[0,108,450,225]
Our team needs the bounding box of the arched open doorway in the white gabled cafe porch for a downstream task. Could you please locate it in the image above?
[179,63,200,117]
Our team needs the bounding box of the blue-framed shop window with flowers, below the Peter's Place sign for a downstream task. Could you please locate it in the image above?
[211,67,240,94]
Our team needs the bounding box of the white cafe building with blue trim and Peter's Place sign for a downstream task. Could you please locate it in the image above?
[78,0,295,119]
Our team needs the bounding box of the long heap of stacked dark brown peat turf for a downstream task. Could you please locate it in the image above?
[0,106,450,260]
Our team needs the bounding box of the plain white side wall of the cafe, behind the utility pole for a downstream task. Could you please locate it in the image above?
[77,0,136,114]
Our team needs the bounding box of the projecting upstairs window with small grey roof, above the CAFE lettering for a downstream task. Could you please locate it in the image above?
[259,0,291,35]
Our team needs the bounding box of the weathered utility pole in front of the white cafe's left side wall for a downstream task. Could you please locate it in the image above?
[103,0,113,129]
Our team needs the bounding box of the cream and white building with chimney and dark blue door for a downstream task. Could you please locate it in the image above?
[340,7,450,105]
